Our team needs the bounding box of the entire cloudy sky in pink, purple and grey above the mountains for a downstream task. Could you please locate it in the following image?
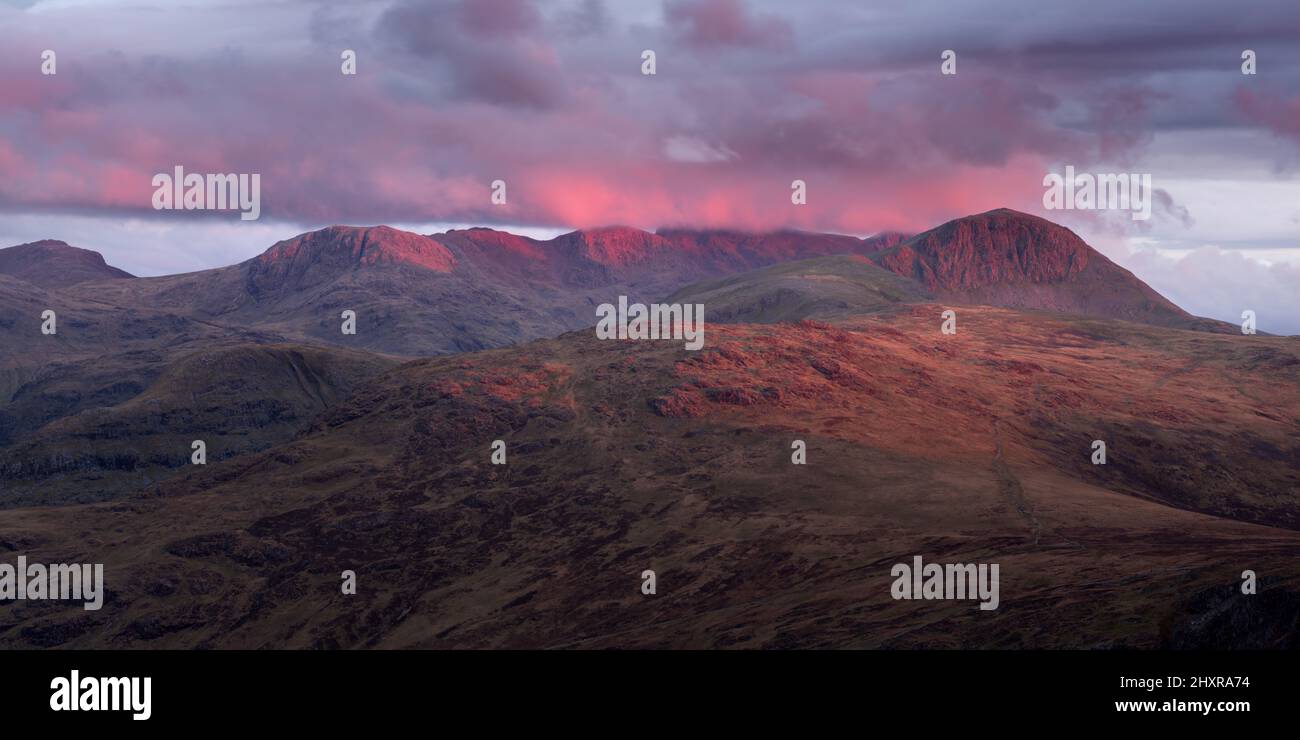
[0,0,1300,333]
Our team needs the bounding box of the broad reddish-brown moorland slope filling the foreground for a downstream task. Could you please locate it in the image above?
[0,304,1300,648]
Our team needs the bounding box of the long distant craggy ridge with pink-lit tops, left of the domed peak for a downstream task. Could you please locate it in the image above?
[22,226,901,356]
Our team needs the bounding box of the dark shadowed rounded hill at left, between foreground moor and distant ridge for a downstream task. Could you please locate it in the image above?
[0,339,395,509]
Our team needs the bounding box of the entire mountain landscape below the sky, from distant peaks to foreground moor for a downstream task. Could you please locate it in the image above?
[0,209,1300,648]
